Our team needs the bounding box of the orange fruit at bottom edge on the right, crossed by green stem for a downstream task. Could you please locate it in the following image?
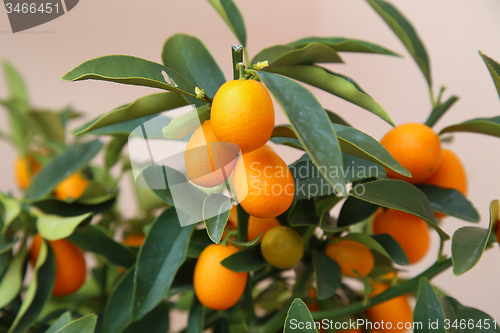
[366,282,413,333]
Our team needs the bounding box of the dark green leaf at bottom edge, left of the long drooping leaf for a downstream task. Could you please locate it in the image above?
[102,268,135,333]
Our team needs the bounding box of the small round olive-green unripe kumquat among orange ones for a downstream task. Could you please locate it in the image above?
[261,226,304,269]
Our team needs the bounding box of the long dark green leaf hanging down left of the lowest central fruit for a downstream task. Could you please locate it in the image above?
[132,208,194,320]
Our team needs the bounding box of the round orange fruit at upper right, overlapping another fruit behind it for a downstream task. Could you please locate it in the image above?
[380,123,441,184]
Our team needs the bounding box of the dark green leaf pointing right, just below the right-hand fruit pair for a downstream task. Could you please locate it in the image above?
[417,184,479,222]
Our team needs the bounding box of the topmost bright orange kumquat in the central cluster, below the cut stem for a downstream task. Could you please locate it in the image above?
[211,80,274,153]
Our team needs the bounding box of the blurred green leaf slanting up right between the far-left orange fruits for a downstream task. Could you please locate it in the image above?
[25,140,103,200]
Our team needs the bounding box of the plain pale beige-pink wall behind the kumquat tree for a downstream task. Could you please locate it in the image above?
[0,0,500,326]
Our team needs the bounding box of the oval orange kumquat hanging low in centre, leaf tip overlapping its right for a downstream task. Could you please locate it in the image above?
[194,244,248,310]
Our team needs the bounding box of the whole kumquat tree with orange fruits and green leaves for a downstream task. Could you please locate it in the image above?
[0,0,500,333]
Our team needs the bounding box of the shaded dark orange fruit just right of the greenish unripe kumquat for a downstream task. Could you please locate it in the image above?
[325,240,375,277]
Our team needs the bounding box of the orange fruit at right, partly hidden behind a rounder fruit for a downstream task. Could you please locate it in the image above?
[424,149,468,218]
